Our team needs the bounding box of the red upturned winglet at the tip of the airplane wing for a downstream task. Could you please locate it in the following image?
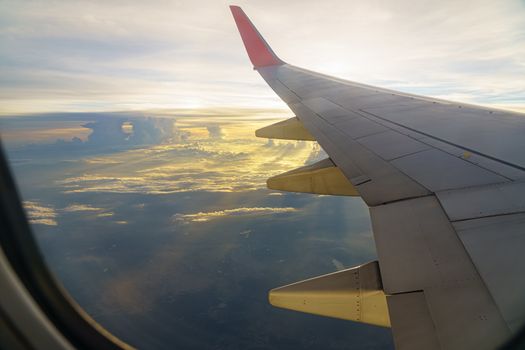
[230,6,283,68]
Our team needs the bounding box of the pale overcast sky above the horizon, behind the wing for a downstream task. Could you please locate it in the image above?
[0,0,525,114]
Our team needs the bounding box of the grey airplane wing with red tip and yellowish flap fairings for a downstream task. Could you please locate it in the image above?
[231,6,525,349]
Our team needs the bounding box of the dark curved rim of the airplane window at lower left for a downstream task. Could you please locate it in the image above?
[0,144,133,350]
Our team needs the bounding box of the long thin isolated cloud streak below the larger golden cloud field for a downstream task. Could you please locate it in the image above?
[172,207,297,224]
